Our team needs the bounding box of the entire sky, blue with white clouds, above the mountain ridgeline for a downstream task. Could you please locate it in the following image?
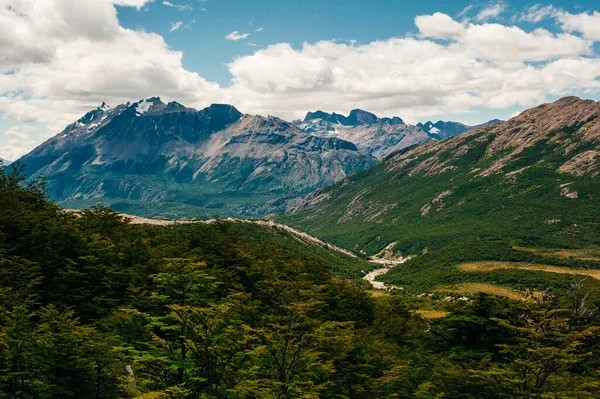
[0,0,600,159]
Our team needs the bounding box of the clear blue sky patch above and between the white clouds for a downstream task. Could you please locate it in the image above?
[119,0,600,85]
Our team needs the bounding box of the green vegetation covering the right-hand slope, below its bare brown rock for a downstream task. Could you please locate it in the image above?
[278,136,600,254]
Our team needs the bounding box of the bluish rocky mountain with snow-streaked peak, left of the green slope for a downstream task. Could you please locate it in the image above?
[21,98,376,217]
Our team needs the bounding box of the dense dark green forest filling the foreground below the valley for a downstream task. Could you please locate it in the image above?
[0,164,600,399]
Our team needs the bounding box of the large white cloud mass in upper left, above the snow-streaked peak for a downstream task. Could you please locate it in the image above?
[0,0,221,159]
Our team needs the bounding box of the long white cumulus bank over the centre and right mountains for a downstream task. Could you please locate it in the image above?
[226,13,600,120]
